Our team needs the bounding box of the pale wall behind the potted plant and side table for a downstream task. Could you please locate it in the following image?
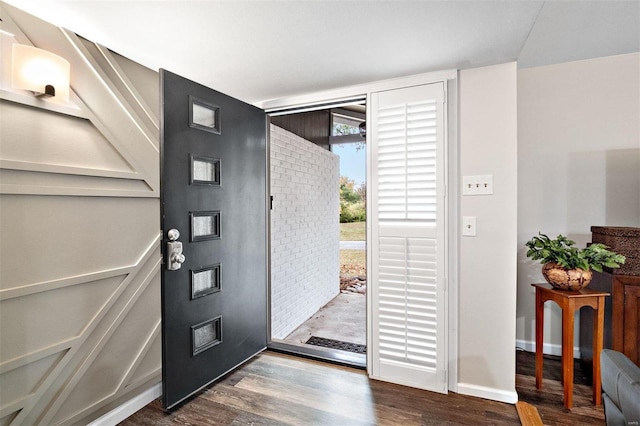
[517,53,640,355]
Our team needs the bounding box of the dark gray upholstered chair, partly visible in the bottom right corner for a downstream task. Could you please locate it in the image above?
[600,349,640,426]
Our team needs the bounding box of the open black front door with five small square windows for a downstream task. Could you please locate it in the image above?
[160,70,267,408]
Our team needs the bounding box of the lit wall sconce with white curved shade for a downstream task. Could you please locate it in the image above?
[11,43,71,102]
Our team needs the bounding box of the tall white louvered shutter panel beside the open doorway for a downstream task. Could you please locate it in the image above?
[370,83,446,392]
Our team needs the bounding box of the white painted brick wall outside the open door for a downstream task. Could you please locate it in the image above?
[271,125,340,339]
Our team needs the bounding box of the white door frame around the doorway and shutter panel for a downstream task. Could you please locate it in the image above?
[255,70,460,392]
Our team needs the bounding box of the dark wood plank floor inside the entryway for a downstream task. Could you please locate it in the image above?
[121,351,604,426]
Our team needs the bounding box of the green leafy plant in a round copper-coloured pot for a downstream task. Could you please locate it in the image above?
[525,233,625,290]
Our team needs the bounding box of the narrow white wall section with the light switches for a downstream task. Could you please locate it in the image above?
[458,63,518,402]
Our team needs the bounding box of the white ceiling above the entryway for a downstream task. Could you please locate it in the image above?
[6,0,640,104]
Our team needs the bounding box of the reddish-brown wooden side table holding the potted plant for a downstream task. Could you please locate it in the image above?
[531,284,609,408]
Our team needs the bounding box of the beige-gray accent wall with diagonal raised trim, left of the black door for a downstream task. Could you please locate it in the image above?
[0,3,161,425]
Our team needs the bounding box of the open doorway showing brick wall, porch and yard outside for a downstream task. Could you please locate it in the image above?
[269,99,367,367]
